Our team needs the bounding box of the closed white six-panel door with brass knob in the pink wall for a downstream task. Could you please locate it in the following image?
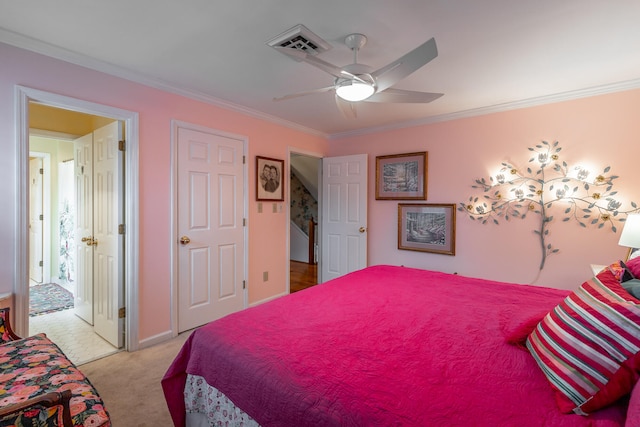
[177,127,245,332]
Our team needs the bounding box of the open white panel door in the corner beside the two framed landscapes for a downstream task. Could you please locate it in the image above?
[320,154,367,282]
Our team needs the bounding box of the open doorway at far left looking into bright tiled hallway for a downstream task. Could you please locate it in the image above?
[29,120,124,364]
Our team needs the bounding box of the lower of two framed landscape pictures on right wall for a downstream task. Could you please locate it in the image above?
[398,204,456,255]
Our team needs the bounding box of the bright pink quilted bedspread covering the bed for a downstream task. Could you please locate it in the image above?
[162,266,627,427]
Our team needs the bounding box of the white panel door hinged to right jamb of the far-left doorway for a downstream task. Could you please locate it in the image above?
[92,121,124,348]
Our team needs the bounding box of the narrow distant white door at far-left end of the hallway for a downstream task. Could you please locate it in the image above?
[29,157,43,283]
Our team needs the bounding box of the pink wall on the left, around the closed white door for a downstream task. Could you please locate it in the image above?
[0,44,327,341]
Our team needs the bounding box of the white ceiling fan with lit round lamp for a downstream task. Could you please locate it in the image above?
[274,33,443,118]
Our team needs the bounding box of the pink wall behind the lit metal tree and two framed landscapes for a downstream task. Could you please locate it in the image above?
[329,90,640,289]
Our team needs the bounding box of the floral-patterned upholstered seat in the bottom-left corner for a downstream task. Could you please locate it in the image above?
[0,334,111,427]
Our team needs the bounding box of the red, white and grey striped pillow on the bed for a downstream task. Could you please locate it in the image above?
[527,269,640,415]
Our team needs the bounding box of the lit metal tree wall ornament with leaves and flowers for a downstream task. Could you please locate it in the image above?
[458,141,639,270]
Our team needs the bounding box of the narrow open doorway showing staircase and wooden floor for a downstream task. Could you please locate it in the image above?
[288,150,322,293]
